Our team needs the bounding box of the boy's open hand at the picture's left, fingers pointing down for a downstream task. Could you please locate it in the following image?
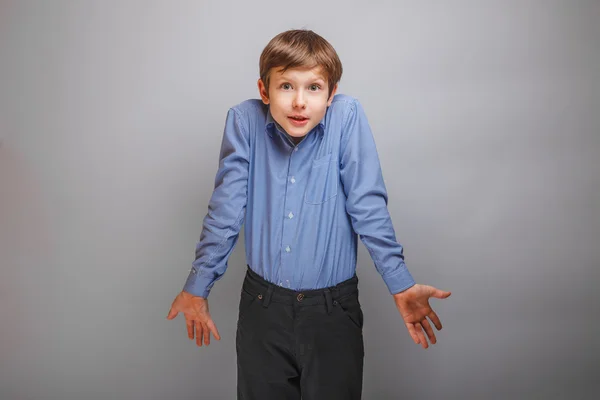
[167,291,221,346]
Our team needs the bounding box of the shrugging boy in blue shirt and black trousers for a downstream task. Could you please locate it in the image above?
[167,30,450,400]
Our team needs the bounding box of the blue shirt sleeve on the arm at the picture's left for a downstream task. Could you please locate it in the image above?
[183,108,250,298]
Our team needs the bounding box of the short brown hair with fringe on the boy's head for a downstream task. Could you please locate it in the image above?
[259,29,342,97]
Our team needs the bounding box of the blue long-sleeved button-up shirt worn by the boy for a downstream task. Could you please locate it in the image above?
[183,94,415,297]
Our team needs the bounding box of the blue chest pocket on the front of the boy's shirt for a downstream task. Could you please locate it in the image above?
[304,153,339,204]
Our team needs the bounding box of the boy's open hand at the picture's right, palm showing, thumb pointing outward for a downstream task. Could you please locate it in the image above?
[393,284,451,349]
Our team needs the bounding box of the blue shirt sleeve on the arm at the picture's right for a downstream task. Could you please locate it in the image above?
[340,99,415,294]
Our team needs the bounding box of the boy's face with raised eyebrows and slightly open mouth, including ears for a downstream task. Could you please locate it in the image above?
[258,67,337,137]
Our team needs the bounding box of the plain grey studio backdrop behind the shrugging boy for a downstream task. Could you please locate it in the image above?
[0,0,600,400]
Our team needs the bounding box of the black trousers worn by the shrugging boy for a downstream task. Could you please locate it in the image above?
[236,267,364,400]
